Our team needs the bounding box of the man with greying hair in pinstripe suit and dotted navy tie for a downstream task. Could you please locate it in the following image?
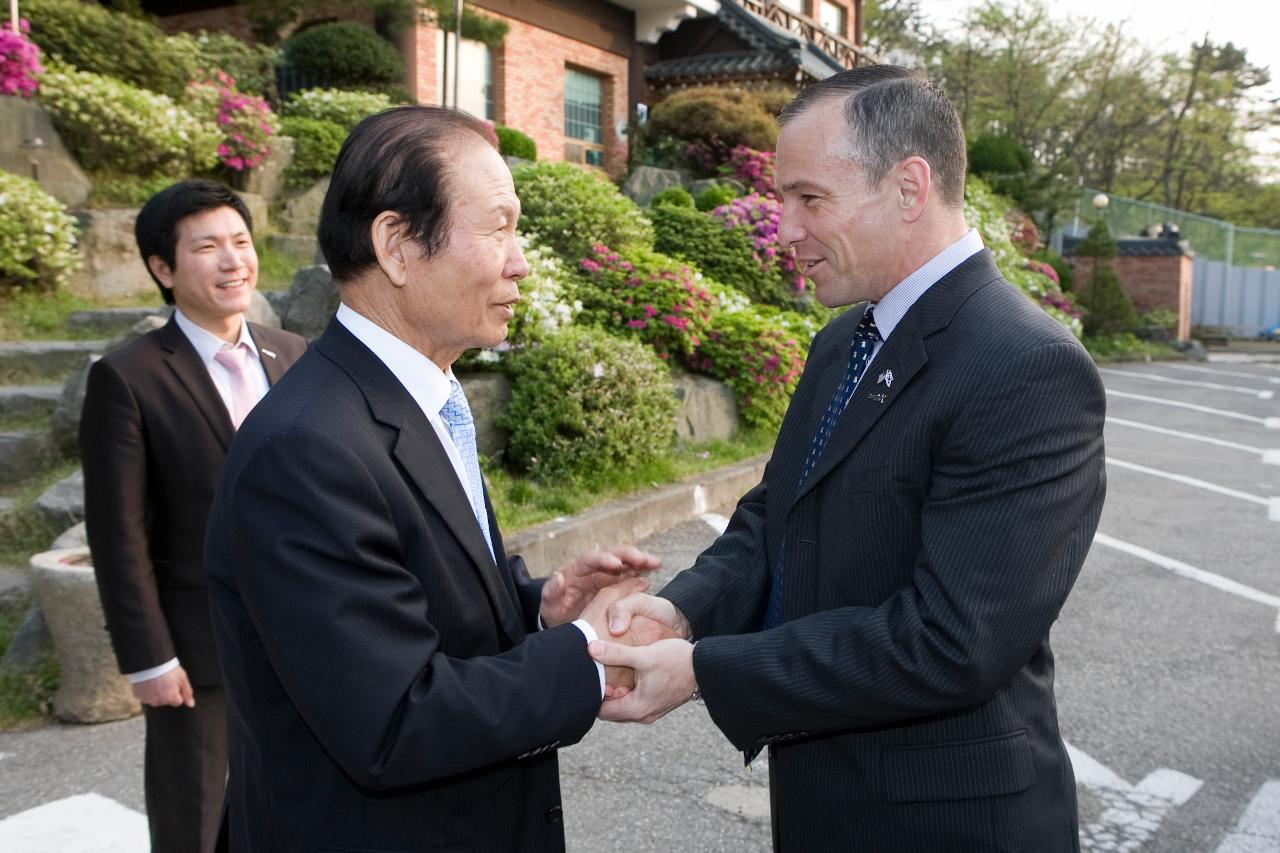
[591,67,1105,853]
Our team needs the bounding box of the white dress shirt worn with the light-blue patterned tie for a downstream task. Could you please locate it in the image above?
[335,302,604,697]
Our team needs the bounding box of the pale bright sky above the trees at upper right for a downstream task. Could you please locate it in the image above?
[920,0,1280,169]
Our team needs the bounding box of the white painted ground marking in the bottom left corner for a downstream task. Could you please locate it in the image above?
[0,794,151,853]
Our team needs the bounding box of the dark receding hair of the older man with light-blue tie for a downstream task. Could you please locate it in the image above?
[319,105,497,283]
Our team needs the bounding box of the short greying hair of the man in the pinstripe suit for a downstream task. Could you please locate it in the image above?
[778,65,968,207]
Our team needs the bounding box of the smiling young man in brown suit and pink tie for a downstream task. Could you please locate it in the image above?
[79,175,306,853]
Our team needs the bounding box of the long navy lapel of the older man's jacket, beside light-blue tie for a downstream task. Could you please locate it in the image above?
[317,320,525,644]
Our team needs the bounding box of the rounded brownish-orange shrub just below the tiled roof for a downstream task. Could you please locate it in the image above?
[648,86,778,163]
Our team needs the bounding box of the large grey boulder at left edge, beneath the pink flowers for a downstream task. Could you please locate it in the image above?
[0,97,92,207]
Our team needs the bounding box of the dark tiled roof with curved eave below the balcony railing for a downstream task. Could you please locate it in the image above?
[644,1,844,81]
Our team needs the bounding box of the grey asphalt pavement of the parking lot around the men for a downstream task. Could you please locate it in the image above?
[0,357,1280,853]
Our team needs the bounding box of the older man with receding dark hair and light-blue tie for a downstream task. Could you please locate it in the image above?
[206,106,658,853]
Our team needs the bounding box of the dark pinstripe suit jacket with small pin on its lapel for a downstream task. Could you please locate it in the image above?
[662,251,1105,853]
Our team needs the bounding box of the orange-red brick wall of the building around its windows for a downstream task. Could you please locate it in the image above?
[410,12,628,175]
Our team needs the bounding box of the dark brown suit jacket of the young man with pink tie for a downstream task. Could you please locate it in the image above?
[79,318,307,686]
